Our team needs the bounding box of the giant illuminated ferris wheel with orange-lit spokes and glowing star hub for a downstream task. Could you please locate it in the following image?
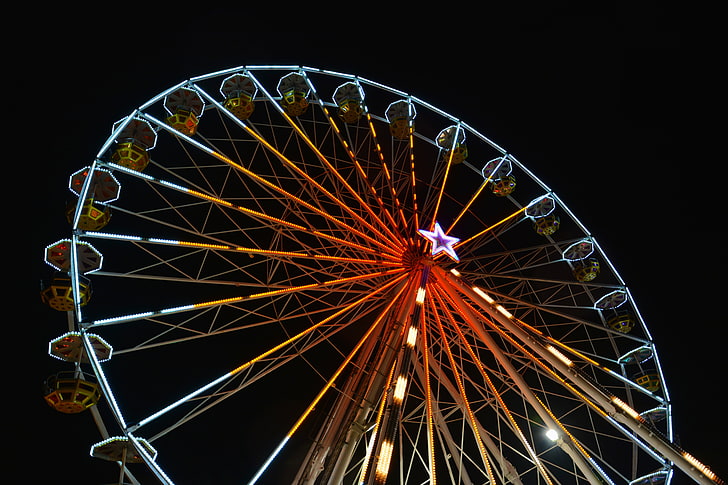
[41,66,724,485]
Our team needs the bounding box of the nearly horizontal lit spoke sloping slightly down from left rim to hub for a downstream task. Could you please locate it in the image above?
[80,231,400,266]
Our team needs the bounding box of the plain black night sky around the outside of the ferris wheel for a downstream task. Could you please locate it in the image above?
[22,2,728,485]
